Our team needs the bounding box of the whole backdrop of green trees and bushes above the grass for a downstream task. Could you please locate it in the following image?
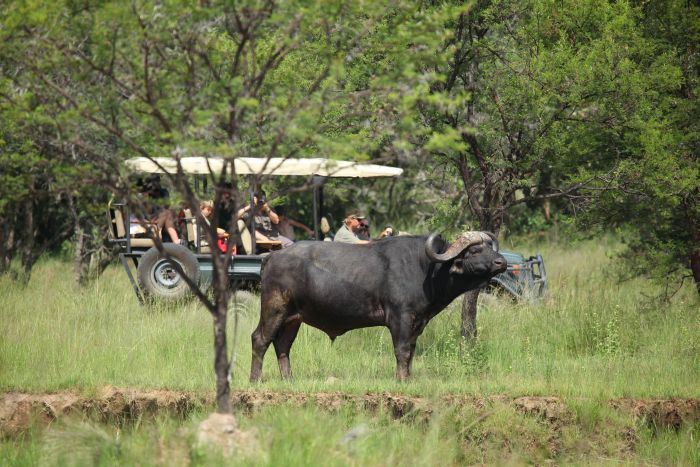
[0,0,700,292]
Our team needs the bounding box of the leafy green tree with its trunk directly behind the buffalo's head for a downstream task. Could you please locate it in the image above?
[404,0,684,336]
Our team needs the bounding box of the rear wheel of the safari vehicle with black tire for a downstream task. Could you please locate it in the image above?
[137,243,200,300]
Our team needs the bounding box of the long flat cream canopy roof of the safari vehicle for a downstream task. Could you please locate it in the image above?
[125,157,403,178]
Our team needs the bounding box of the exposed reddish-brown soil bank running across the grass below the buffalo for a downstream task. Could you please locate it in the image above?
[0,386,700,437]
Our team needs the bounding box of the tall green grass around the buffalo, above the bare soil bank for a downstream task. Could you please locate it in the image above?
[0,241,700,398]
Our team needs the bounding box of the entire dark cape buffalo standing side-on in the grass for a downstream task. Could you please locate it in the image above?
[250,232,506,381]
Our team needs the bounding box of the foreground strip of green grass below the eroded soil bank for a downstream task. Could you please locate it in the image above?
[0,402,700,467]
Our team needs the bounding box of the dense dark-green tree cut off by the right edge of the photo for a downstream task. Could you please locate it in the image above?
[581,1,700,297]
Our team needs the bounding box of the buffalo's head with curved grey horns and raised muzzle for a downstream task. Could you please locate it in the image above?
[425,232,507,276]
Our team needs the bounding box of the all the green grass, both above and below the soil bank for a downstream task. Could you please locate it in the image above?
[0,241,700,466]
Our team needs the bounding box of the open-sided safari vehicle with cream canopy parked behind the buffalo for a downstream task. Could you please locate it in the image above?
[108,157,546,303]
